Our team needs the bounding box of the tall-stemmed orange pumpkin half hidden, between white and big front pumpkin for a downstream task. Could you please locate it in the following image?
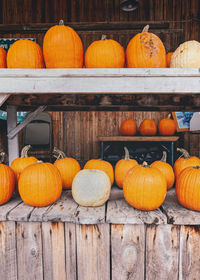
[114,147,138,188]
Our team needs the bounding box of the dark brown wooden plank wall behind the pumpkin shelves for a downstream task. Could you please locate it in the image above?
[0,0,200,161]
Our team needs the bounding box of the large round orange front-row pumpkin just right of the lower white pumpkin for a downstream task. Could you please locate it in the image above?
[123,163,167,211]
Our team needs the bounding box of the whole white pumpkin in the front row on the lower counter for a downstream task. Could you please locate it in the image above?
[72,169,111,206]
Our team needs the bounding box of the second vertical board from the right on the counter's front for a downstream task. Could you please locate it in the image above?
[146,225,181,280]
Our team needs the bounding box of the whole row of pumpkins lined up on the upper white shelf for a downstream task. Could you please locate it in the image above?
[0,20,200,68]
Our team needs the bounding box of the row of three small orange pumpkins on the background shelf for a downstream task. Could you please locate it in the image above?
[120,114,176,136]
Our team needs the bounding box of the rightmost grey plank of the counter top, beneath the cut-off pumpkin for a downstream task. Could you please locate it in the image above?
[162,188,200,225]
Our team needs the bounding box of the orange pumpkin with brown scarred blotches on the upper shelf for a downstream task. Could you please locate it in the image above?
[126,25,166,68]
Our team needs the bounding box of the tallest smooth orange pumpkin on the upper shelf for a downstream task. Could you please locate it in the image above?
[43,20,83,68]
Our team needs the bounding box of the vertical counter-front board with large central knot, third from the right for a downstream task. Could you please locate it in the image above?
[111,225,145,280]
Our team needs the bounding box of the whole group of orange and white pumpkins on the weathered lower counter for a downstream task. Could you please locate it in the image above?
[0,146,200,211]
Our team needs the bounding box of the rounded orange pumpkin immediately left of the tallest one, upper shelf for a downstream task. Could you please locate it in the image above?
[7,40,44,68]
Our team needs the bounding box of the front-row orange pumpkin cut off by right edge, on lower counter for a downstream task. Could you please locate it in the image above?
[176,166,200,211]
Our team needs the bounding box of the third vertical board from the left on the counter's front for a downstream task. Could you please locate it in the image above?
[42,223,66,280]
